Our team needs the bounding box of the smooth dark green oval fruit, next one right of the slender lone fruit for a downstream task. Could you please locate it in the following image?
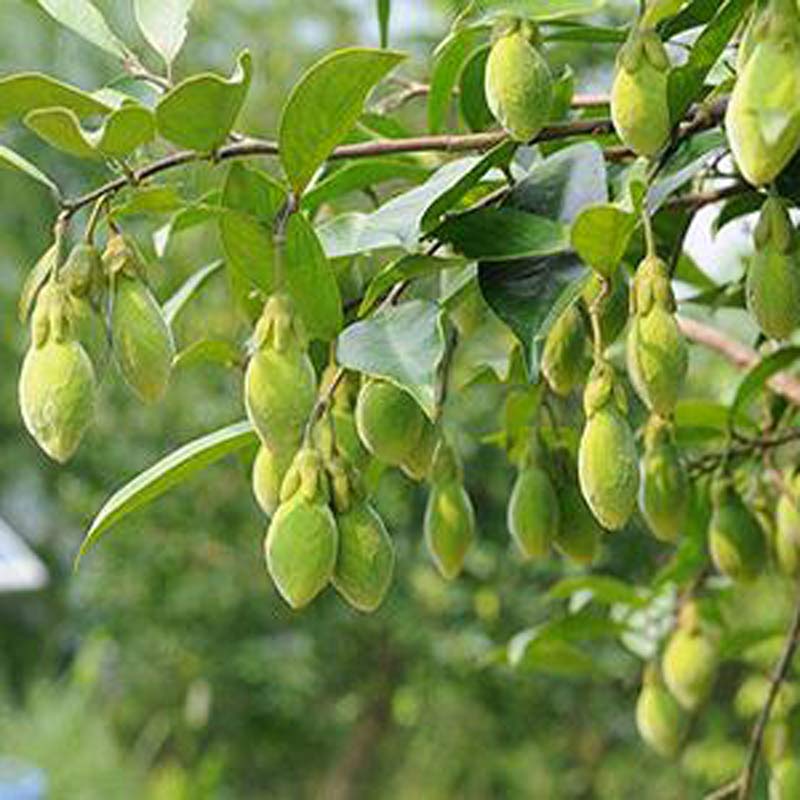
[507,464,560,558]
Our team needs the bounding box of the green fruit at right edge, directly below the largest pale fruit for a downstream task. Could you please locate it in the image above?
[746,197,800,339]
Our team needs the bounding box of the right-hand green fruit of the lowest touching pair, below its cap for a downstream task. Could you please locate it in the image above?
[331,502,394,612]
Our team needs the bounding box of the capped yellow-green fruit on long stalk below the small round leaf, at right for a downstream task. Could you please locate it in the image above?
[627,256,689,417]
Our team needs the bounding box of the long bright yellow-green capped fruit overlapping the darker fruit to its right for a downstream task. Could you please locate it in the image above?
[578,362,639,530]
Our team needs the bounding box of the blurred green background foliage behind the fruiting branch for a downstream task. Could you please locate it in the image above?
[0,0,785,800]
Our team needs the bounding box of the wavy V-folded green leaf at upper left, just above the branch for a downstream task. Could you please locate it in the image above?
[25,104,156,159]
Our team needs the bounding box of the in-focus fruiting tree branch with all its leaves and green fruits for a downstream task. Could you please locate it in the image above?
[7,0,800,798]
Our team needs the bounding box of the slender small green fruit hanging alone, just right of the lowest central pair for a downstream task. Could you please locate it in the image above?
[424,441,475,580]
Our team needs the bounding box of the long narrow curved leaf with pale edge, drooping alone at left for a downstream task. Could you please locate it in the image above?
[76,421,258,566]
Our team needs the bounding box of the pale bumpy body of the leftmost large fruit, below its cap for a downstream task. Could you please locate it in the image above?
[19,336,95,463]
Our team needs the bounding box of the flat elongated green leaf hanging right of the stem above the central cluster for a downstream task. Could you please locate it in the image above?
[283,213,343,341]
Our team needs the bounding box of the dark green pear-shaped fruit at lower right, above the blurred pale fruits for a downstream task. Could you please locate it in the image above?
[708,481,767,581]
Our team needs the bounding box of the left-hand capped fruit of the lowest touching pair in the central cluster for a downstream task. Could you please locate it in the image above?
[264,449,339,609]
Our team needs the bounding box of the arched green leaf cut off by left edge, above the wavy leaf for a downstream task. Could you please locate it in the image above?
[0,72,112,124]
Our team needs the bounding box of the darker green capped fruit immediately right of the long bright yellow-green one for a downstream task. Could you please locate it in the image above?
[639,417,691,542]
